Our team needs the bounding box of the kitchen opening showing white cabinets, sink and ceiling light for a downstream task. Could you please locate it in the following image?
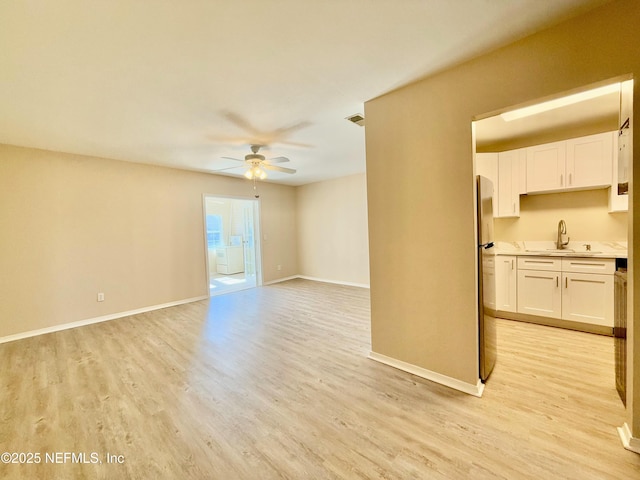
[472,77,633,402]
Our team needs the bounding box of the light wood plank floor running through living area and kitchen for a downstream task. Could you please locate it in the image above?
[0,280,640,480]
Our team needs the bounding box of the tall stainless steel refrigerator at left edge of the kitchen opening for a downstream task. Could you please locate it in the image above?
[476,175,497,382]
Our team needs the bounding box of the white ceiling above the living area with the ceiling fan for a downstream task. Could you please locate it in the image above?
[0,0,606,185]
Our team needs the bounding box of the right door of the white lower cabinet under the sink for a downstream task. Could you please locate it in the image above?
[562,273,614,327]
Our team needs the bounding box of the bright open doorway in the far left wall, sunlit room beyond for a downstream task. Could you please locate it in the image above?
[204,195,262,296]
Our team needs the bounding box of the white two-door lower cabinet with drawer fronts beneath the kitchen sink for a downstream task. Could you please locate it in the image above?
[512,256,615,327]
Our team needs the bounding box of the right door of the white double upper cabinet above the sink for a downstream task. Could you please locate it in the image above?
[565,132,613,188]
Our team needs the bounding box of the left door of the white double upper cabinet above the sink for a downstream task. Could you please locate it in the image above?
[527,142,566,193]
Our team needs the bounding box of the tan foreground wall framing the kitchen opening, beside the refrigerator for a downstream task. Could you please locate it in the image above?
[365,0,640,436]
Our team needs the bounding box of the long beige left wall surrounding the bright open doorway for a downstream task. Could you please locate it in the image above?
[0,145,298,337]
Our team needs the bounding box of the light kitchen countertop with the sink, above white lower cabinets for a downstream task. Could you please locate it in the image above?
[495,240,627,258]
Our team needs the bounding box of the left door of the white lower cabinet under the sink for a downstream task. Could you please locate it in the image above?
[518,270,562,318]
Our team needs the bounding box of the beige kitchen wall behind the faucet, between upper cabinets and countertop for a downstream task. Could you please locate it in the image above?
[494,189,628,242]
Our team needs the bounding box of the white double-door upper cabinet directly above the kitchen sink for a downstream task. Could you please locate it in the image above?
[527,132,614,193]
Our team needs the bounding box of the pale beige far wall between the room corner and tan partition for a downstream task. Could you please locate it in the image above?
[297,174,369,285]
